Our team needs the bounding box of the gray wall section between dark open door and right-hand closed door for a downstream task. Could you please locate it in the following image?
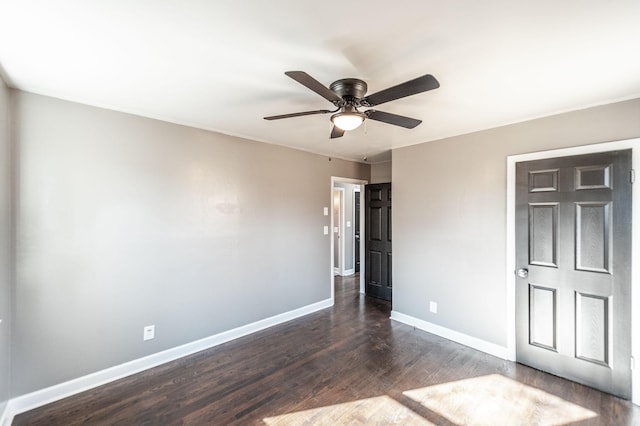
[393,99,640,346]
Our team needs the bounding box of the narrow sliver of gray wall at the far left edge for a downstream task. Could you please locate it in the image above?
[0,79,12,414]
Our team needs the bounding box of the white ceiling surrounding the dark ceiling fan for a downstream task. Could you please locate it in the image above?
[0,0,640,161]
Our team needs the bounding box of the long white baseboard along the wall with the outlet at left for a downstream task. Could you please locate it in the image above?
[0,299,333,426]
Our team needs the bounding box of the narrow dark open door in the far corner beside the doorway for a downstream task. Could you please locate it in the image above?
[365,183,392,301]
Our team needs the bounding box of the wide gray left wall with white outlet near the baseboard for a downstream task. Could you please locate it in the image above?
[11,92,370,396]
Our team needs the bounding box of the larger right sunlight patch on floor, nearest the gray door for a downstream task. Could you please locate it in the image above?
[403,374,597,425]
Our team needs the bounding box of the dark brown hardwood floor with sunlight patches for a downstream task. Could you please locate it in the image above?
[13,277,640,425]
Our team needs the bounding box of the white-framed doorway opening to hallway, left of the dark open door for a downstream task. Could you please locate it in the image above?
[330,177,367,300]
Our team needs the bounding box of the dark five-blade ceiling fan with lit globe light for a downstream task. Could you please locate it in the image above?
[264,71,440,139]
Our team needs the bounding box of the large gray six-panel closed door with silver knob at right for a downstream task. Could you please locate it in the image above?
[516,150,631,399]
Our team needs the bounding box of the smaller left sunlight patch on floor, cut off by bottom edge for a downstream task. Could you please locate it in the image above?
[263,396,433,426]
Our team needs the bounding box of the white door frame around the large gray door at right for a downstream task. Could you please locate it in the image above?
[506,138,640,405]
